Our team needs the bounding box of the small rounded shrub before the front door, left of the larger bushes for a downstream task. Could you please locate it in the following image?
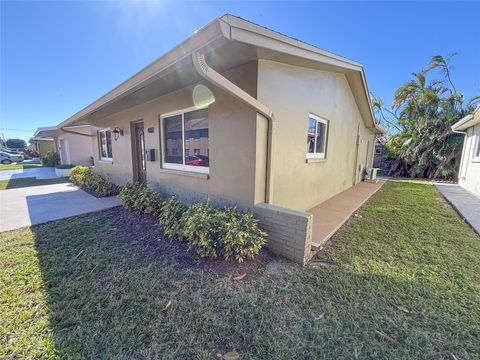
[120,182,162,216]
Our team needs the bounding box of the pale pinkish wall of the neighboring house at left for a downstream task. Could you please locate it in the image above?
[56,127,93,165]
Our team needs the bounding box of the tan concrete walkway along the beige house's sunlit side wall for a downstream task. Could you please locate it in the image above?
[307,180,385,249]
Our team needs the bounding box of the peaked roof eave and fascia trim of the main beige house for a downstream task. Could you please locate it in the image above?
[58,15,384,134]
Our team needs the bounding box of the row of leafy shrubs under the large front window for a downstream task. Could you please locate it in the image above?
[120,183,266,262]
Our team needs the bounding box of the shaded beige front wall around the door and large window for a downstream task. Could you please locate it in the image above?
[92,63,257,208]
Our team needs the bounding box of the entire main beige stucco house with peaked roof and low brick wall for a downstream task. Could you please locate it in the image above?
[59,15,382,262]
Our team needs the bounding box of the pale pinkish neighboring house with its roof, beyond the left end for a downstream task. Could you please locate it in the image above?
[30,125,96,165]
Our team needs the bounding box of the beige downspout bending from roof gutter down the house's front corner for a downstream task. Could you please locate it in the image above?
[192,52,275,204]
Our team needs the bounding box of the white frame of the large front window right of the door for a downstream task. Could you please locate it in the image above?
[160,106,210,174]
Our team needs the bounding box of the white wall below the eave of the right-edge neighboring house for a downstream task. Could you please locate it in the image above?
[458,124,480,195]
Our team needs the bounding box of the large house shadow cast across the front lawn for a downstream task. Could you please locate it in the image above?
[32,198,480,359]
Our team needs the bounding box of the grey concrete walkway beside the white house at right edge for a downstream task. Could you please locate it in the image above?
[434,183,480,235]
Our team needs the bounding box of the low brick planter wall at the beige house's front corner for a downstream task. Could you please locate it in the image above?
[253,204,313,264]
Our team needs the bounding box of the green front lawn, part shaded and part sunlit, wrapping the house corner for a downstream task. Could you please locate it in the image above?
[0,181,480,359]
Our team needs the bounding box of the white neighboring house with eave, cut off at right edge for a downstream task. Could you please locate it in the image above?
[452,106,480,195]
